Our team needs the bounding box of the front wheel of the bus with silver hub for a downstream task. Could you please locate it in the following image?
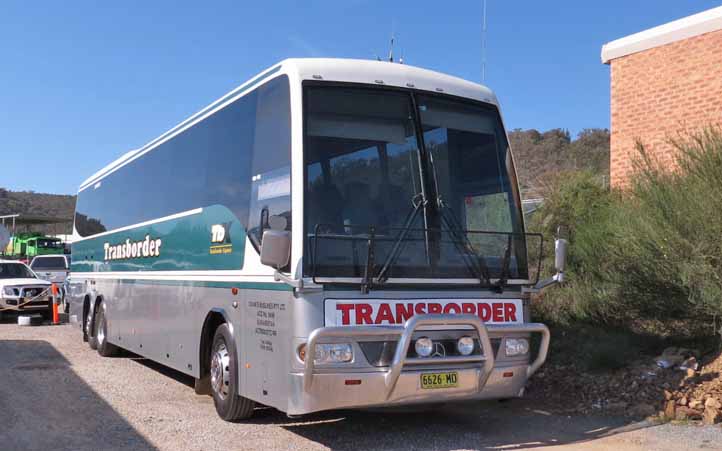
[209,324,256,421]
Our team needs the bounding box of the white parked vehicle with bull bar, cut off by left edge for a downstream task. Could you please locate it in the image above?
[0,260,53,318]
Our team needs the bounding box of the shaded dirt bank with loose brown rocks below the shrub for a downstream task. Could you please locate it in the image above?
[527,338,722,424]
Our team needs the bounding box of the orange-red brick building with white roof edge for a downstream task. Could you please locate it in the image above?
[602,7,722,186]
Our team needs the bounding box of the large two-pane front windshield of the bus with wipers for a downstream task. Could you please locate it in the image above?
[304,85,527,282]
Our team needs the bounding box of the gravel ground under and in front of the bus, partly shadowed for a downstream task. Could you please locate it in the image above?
[0,319,722,451]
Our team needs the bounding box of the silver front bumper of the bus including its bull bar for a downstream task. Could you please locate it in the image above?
[288,315,550,415]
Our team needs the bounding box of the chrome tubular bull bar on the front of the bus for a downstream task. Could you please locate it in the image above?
[303,314,550,399]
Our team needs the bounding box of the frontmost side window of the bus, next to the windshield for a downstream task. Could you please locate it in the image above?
[248,77,291,251]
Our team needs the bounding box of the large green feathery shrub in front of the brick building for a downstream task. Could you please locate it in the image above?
[530,129,722,334]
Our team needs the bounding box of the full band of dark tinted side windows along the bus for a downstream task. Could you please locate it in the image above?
[75,76,291,244]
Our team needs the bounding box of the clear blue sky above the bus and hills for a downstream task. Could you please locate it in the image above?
[0,0,720,193]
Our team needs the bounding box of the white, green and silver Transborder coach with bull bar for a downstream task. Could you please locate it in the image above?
[68,59,566,421]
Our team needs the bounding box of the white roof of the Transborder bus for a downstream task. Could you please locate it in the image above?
[79,58,498,191]
